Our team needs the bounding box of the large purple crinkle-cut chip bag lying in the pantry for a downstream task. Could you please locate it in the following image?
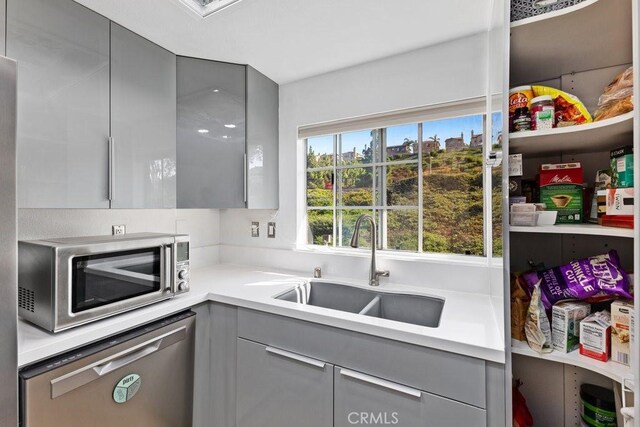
[524,250,632,310]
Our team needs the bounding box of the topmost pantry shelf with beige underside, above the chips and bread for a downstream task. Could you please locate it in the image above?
[510,0,633,86]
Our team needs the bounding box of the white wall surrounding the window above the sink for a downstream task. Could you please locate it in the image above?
[220,33,500,293]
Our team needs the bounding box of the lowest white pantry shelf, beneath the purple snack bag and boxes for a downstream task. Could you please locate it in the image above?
[511,339,633,384]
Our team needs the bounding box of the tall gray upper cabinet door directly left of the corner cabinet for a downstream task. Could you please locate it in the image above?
[111,23,176,208]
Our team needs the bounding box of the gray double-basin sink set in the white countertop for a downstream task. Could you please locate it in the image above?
[274,281,444,328]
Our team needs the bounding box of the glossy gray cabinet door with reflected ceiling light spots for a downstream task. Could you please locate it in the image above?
[177,57,247,208]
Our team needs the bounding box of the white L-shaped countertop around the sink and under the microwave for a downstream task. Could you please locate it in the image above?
[18,265,505,366]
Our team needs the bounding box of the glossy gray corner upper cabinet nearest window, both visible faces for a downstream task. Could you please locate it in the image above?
[177,57,278,209]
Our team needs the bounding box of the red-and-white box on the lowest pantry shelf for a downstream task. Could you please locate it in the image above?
[580,310,611,362]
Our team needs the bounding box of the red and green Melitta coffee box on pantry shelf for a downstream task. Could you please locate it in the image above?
[540,162,584,224]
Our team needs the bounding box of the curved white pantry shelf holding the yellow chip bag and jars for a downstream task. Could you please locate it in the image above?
[509,112,633,156]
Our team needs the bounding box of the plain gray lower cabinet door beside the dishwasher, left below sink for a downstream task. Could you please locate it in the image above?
[236,339,334,427]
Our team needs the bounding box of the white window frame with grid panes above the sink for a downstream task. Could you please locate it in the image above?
[296,98,501,264]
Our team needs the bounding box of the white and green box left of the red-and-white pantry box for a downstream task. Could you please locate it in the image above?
[551,301,591,353]
